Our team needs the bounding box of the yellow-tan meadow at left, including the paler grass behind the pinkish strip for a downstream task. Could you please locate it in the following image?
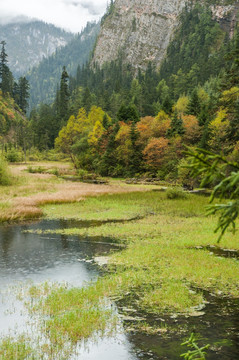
[0,162,150,223]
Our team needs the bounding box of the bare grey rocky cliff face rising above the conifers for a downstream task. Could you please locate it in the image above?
[93,0,239,69]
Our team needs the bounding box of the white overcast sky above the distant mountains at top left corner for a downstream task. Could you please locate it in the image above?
[0,0,109,32]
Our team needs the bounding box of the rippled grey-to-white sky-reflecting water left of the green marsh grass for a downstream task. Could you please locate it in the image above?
[0,221,137,360]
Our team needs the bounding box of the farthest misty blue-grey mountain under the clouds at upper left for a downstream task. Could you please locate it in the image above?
[0,20,74,77]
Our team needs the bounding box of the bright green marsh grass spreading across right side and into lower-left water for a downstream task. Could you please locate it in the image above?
[26,192,239,348]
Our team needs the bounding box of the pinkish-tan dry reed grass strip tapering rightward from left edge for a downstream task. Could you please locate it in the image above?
[0,163,149,222]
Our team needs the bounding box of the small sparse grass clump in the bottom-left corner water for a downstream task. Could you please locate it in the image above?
[0,335,36,360]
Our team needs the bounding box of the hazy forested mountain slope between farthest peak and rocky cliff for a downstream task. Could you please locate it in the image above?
[26,23,100,109]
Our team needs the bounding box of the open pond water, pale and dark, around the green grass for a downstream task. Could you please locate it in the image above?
[0,220,239,360]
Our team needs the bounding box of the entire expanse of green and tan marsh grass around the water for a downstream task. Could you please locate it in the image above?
[0,164,239,359]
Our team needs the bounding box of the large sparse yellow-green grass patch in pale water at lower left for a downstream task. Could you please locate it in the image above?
[30,285,117,348]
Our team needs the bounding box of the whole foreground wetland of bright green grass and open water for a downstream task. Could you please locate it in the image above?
[0,167,239,360]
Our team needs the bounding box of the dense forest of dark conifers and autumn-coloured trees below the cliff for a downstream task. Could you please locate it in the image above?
[2,4,239,182]
